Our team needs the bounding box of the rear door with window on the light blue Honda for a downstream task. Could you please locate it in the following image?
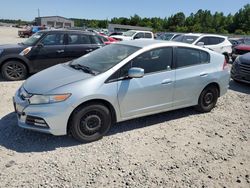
[174,47,212,108]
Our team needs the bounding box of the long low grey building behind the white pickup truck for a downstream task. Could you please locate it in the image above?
[108,24,153,32]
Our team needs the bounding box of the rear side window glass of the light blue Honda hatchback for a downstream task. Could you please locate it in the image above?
[176,47,210,68]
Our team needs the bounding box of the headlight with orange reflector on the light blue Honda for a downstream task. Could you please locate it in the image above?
[29,93,71,104]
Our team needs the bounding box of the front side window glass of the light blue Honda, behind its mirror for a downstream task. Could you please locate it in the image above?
[121,48,172,77]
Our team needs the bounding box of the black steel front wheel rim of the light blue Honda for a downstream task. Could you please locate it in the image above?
[80,114,102,135]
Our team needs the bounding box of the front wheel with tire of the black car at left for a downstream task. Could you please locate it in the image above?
[1,61,28,81]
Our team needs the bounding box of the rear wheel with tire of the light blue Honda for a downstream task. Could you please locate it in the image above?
[196,86,219,112]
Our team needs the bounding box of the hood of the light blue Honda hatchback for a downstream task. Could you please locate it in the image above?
[23,64,93,94]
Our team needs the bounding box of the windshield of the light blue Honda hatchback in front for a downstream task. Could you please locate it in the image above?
[70,44,140,73]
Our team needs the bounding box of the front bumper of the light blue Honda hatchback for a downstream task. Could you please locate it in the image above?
[13,91,73,135]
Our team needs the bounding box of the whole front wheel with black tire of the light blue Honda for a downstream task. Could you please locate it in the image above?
[69,103,111,142]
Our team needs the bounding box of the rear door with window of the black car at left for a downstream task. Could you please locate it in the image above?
[65,33,102,61]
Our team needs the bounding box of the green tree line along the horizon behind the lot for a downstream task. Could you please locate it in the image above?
[0,4,250,35]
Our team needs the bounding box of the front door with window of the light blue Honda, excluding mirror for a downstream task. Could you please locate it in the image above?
[118,48,175,119]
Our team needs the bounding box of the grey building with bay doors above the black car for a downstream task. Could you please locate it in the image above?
[35,16,74,28]
